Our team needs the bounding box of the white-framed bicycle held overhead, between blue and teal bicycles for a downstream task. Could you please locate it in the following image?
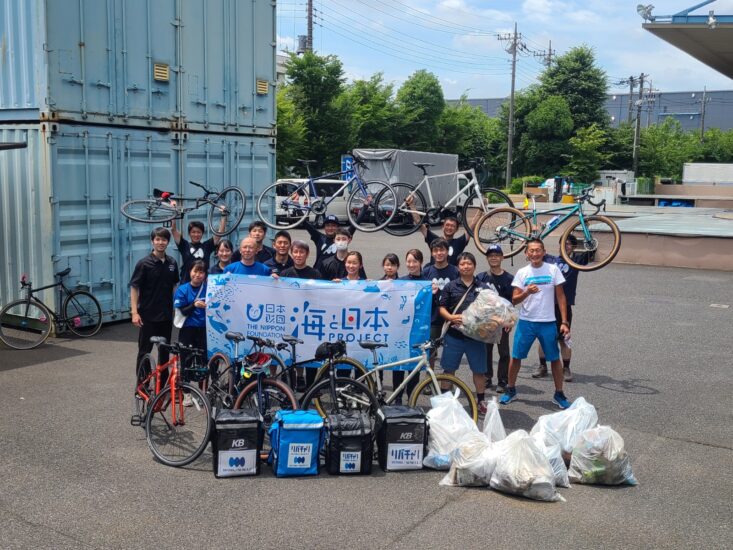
[377,162,514,237]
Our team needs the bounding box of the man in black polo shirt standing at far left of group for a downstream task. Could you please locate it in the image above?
[130,227,178,382]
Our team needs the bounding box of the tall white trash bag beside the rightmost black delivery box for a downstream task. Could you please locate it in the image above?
[423,392,480,470]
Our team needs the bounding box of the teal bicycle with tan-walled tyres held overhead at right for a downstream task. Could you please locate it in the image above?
[476,187,621,271]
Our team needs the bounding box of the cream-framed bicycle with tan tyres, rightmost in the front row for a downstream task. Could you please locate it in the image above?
[357,338,478,422]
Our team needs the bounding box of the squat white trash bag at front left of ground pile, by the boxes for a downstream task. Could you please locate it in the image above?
[440,431,496,487]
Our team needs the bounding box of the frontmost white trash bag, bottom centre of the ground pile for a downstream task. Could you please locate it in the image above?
[490,430,565,502]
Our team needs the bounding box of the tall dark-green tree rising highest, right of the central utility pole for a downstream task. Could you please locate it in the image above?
[540,46,608,131]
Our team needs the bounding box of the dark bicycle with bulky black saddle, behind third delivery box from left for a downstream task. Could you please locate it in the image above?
[300,340,379,426]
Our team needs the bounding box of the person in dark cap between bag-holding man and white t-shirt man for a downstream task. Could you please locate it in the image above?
[476,244,514,393]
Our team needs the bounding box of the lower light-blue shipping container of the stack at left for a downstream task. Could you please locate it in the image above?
[0,123,275,321]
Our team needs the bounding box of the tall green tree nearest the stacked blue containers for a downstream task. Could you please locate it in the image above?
[286,52,351,170]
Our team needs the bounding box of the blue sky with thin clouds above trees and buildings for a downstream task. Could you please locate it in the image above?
[277,0,733,99]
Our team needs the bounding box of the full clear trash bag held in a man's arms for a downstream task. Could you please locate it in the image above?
[458,288,519,344]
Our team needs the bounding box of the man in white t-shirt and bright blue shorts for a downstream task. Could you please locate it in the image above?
[499,239,570,409]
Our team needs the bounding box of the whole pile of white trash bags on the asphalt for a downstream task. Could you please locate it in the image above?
[424,393,637,502]
